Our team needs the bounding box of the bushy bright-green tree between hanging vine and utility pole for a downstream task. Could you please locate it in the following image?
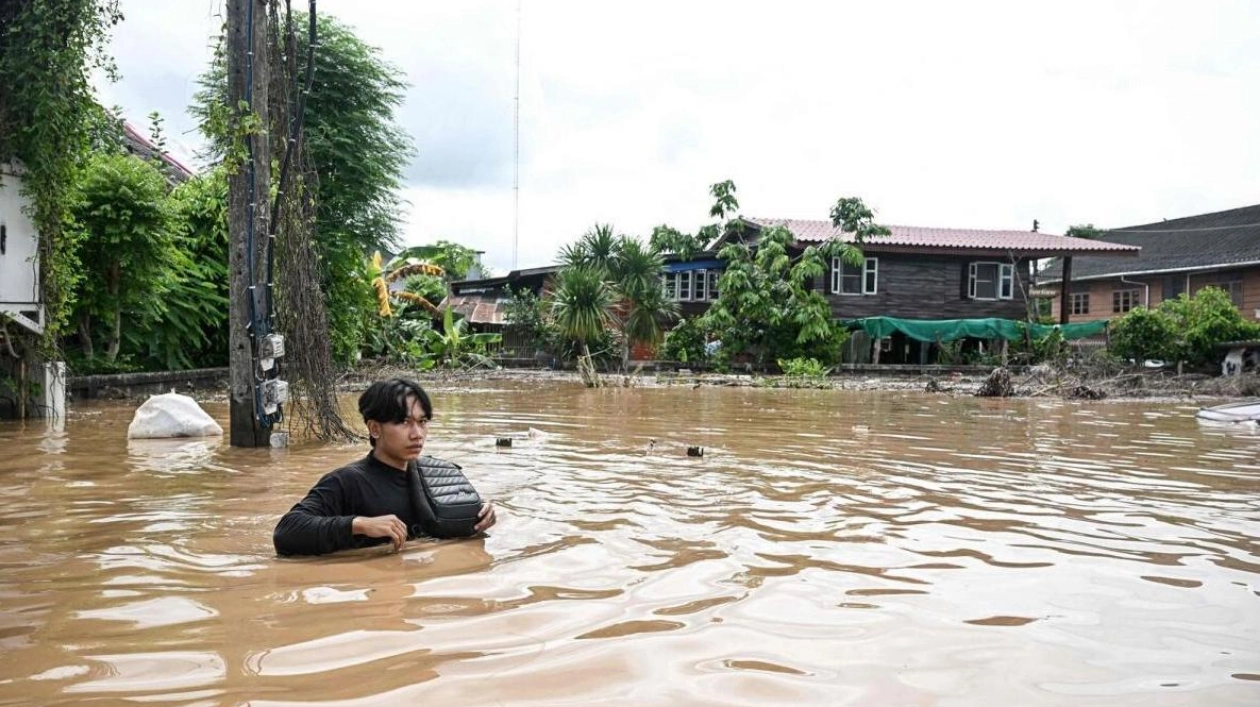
[73,152,176,364]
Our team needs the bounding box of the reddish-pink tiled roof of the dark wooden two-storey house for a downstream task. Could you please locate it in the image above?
[743,218,1138,255]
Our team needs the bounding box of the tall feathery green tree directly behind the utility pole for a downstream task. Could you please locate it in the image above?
[190,15,415,362]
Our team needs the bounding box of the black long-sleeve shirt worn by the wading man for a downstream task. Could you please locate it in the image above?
[272,454,421,555]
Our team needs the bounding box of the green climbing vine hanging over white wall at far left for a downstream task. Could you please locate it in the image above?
[0,0,122,350]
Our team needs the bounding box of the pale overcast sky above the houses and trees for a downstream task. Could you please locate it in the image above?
[98,0,1260,271]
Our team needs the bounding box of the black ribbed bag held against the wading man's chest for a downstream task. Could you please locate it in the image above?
[407,456,481,538]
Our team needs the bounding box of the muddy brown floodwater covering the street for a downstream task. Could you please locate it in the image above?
[0,382,1260,707]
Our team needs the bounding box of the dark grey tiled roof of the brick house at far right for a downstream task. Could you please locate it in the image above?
[1038,204,1260,282]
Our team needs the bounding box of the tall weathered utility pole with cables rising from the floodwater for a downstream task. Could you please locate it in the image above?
[227,0,271,447]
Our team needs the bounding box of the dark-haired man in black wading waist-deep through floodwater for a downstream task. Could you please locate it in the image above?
[272,378,496,555]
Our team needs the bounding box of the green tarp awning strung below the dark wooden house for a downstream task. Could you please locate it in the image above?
[842,316,1108,342]
